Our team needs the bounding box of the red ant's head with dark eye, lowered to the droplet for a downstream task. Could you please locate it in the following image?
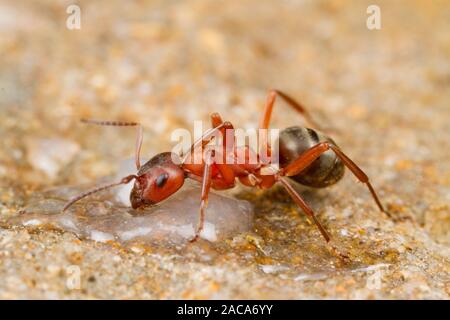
[130,152,185,209]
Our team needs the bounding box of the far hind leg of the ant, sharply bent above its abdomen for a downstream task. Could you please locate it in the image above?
[259,90,320,130]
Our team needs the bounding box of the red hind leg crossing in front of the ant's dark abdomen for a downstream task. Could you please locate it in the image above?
[278,142,391,217]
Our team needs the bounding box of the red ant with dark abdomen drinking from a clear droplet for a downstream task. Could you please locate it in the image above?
[63,90,390,243]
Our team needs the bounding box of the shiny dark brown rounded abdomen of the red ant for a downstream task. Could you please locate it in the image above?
[279,126,345,188]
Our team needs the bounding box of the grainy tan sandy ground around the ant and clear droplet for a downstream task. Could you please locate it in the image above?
[0,0,450,299]
